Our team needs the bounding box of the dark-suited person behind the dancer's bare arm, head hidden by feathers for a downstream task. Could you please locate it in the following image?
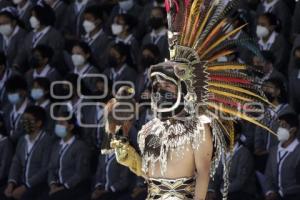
[207,122,255,200]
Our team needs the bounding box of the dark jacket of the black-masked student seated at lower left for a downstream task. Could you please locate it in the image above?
[8,132,52,187]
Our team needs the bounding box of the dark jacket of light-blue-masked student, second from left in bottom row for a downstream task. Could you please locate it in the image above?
[48,139,90,188]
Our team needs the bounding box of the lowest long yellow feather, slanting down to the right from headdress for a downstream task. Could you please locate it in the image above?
[207,102,276,136]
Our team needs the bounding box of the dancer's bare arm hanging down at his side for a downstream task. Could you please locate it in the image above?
[194,124,213,200]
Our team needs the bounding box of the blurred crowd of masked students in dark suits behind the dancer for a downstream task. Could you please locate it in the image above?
[0,0,300,200]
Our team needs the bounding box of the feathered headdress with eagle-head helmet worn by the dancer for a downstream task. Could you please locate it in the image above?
[149,0,274,198]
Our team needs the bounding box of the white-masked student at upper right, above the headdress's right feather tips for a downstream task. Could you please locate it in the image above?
[256,13,290,74]
